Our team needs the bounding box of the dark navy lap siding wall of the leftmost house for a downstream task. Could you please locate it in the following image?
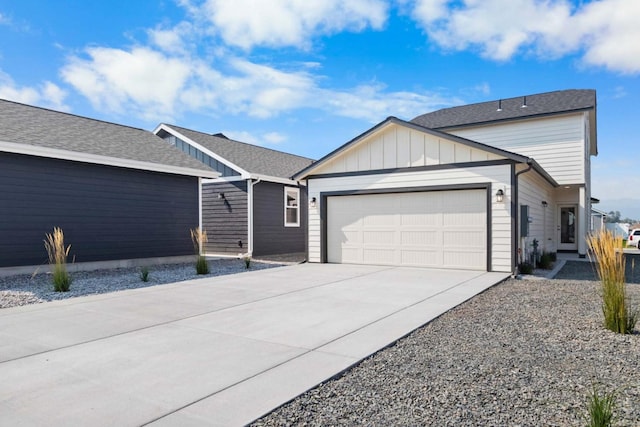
[0,153,198,267]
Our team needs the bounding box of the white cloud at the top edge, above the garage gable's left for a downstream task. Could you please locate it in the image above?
[198,0,388,49]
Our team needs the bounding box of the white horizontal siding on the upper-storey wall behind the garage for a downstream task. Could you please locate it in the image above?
[448,113,588,185]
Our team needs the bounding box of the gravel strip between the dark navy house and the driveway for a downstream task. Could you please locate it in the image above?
[0,259,283,309]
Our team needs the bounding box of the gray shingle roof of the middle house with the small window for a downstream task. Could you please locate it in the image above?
[165,125,314,178]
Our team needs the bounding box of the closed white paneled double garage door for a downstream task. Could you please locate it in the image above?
[327,190,487,270]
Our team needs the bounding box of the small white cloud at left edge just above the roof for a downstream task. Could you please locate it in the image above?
[0,70,69,111]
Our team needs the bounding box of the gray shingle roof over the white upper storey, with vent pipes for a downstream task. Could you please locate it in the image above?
[411,89,596,129]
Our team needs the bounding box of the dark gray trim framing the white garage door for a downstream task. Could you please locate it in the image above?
[319,182,492,271]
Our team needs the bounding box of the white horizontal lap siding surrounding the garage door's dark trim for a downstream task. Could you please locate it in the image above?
[308,165,512,271]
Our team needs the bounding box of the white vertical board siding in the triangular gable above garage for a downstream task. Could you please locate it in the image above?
[314,124,501,174]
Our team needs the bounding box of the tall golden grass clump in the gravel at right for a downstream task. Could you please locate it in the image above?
[587,230,638,334]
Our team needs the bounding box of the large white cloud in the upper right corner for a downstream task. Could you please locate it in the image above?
[412,0,640,73]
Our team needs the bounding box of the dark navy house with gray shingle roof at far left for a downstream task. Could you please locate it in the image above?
[0,100,219,267]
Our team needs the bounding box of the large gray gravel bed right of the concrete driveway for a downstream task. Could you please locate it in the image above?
[253,262,640,426]
